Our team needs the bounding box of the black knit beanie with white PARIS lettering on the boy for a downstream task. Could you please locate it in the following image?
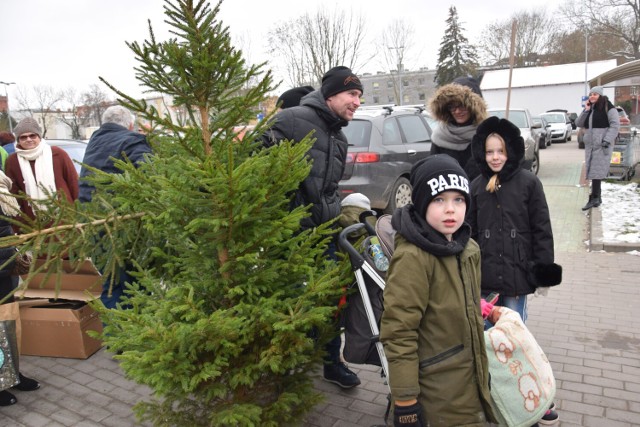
[409,154,471,217]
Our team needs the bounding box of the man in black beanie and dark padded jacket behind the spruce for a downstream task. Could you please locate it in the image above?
[262,66,363,388]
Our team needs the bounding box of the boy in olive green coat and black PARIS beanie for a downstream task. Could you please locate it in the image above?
[380,154,495,427]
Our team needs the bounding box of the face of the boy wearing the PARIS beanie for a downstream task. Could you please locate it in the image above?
[426,190,467,241]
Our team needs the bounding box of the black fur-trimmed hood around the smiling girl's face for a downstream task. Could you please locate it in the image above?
[471,116,524,182]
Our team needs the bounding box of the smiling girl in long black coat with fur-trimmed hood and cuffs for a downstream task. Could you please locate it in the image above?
[467,117,562,424]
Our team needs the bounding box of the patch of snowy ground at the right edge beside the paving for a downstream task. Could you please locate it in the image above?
[599,181,640,243]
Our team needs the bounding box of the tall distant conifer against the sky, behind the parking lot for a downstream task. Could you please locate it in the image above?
[434,6,478,86]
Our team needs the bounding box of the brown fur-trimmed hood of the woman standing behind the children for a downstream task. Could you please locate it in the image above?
[429,83,487,126]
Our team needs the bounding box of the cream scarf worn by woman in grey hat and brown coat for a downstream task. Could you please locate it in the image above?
[16,140,56,207]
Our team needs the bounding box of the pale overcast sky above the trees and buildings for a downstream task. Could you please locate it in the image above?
[0,0,561,102]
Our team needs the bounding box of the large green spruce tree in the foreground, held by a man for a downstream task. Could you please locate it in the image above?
[0,0,348,426]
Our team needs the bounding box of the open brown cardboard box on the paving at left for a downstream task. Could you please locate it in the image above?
[16,260,103,359]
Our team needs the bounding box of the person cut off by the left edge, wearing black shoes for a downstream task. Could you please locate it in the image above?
[0,171,40,406]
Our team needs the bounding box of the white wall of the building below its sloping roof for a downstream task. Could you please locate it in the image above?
[482,83,615,116]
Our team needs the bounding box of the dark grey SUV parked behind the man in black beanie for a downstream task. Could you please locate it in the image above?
[340,106,431,213]
